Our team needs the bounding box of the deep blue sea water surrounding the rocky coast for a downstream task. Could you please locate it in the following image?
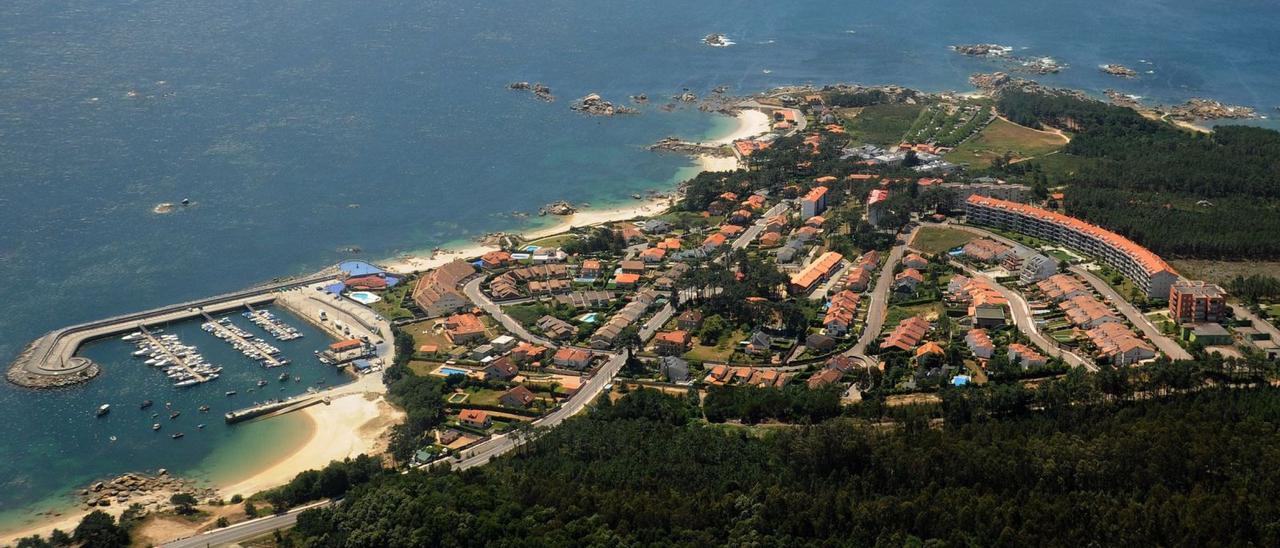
[0,0,1280,527]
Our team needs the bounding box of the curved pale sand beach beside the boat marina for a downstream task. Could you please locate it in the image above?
[219,393,402,498]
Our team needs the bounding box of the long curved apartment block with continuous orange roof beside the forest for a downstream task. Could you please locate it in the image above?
[965,195,1178,300]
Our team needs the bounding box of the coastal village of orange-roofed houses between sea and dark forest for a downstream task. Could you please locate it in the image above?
[2,78,1280,548]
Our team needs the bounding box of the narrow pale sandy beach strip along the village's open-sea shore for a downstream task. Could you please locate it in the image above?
[379,109,771,274]
